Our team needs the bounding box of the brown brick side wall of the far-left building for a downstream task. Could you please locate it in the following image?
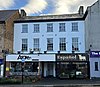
[4,12,20,53]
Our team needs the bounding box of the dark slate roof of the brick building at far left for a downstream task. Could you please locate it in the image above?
[0,10,18,22]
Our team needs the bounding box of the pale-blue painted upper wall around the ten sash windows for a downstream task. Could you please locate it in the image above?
[13,21,85,53]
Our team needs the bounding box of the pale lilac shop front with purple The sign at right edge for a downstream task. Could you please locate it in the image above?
[89,51,100,79]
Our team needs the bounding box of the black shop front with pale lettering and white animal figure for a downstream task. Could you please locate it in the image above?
[56,54,90,79]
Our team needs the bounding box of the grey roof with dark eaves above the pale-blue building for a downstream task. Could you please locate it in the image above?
[15,13,84,23]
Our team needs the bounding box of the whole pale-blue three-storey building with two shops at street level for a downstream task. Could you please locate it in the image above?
[6,6,90,79]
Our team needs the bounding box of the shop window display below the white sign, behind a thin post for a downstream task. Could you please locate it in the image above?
[10,62,38,75]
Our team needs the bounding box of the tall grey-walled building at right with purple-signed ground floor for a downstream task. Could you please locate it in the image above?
[85,0,100,78]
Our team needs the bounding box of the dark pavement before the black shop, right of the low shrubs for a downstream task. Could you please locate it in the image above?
[34,78,100,87]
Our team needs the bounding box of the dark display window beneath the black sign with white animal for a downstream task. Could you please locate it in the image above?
[57,62,88,79]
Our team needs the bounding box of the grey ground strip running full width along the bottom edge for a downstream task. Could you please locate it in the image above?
[0,78,100,87]
